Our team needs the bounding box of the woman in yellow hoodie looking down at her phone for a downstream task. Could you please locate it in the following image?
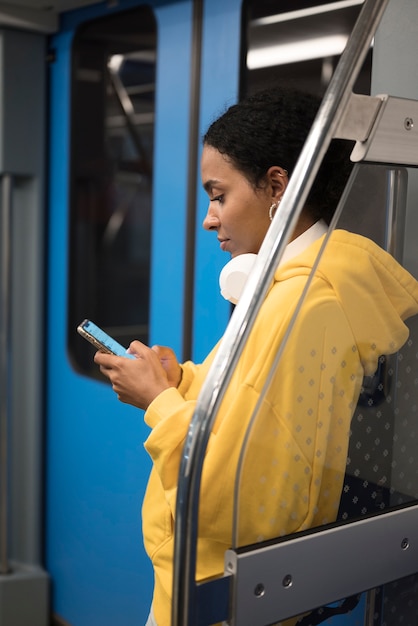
[95,89,418,626]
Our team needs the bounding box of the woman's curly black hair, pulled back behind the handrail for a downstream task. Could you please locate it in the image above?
[203,86,352,223]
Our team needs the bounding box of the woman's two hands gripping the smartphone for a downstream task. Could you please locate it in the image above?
[94,341,181,409]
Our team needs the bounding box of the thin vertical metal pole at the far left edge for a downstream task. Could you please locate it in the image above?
[0,174,12,574]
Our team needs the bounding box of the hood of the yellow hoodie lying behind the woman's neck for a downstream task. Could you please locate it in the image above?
[275,230,418,376]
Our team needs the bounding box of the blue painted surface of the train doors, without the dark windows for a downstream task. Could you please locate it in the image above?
[46,0,240,626]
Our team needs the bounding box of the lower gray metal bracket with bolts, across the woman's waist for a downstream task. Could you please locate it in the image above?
[225,505,418,626]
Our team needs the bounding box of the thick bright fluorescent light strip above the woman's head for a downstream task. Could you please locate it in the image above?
[247,35,348,70]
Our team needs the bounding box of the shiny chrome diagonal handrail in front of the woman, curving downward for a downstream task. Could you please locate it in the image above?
[172,0,389,626]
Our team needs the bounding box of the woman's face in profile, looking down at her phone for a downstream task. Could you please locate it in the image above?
[201,145,287,257]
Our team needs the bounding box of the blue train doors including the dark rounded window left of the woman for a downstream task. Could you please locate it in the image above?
[45,0,240,626]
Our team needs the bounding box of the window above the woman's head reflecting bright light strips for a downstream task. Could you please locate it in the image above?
[241,0,371,96]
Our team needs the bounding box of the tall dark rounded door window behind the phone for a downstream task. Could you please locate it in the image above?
[68,6,157,377]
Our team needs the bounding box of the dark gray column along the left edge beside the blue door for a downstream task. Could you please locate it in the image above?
[0,29,49,626]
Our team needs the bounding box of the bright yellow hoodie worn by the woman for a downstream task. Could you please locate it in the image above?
[143,230,418,626]
